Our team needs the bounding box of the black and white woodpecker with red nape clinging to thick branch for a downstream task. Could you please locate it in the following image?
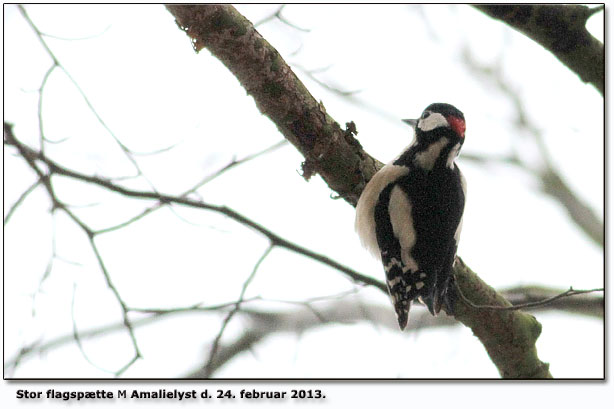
[355,103,467,330]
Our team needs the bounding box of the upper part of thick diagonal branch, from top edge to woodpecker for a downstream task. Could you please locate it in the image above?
[167,5,380,205]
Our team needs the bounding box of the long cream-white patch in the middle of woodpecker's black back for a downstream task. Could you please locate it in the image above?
[388,186,418,272]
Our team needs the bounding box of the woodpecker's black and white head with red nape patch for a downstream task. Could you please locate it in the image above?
[403,103,465,145]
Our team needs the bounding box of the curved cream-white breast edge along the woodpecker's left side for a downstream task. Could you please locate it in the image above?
[354,163,409,260]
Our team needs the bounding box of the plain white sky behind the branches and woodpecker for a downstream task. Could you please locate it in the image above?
[4,5,604,388]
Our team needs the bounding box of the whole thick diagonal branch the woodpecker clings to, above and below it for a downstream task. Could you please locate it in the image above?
[167,5,564,378]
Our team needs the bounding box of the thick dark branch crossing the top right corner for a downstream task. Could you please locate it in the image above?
[474,4,605,96]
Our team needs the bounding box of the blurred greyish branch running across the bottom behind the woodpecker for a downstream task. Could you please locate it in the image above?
[4,287,604,378]
